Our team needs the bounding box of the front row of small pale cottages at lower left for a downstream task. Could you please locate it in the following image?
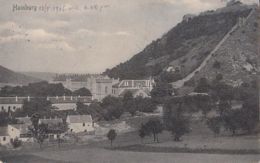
[0,115,95,145]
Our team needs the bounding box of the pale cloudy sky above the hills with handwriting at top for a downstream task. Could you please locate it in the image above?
[0,0,257,73]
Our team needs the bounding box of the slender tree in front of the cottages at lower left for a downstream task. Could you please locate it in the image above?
[29,113,48,148]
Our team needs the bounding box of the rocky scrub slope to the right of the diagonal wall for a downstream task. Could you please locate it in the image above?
[194,10,259,84]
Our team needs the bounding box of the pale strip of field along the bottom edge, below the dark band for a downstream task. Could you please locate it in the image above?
[32,148,260,163]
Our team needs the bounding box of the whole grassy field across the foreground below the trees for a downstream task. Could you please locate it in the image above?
[0,118,260,163]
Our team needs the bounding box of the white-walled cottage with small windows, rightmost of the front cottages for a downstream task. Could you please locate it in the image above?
[66,115,95,133]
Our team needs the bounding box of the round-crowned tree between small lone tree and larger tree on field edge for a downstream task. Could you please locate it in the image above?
[143,119,163,142]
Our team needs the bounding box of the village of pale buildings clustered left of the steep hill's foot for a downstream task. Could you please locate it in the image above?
[0,75,158,147]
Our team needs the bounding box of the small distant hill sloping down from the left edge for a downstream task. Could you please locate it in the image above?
[0,65,41,85]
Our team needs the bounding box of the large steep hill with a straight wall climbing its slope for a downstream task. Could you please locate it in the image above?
[104,3,259,87]
